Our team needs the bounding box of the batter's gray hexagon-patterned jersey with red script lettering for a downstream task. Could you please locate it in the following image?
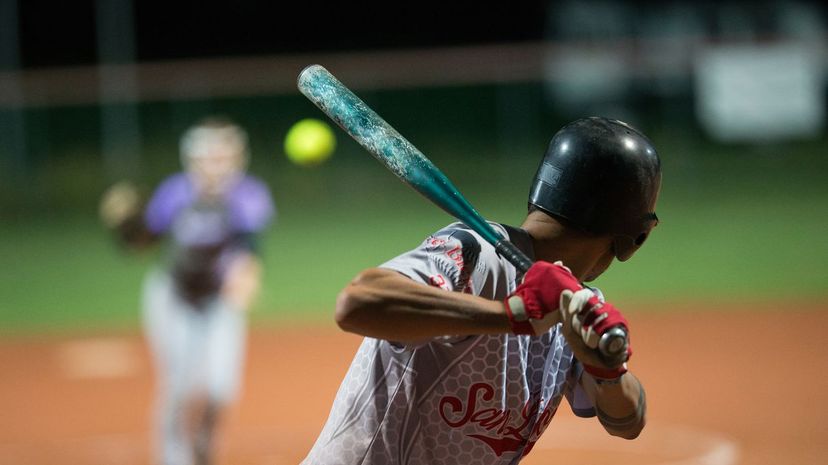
[303,223,593,465]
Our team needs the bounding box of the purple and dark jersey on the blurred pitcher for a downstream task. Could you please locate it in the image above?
[145,173,276,303]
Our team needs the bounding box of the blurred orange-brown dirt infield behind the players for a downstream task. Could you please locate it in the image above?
[0,308,828,465]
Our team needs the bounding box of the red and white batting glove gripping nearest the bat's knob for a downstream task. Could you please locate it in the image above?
[560,289,632,379]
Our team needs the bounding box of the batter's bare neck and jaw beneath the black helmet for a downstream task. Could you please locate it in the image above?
[521,212,606,281]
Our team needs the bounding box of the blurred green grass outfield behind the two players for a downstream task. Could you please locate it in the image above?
[0,134,828,332]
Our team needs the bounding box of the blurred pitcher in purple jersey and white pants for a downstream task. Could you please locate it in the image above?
[101,118,275,465]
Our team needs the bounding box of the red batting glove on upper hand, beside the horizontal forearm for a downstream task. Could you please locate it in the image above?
[505,261,581,336]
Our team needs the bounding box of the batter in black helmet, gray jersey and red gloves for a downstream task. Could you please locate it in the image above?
[304,118,661,465]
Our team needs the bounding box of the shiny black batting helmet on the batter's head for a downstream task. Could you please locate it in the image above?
[529,117,661,261]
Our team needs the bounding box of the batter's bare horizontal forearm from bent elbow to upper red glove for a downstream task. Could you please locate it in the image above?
[336,268,511,342]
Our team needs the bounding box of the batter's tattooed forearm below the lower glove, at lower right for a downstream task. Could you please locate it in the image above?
[582,372,647,439]
